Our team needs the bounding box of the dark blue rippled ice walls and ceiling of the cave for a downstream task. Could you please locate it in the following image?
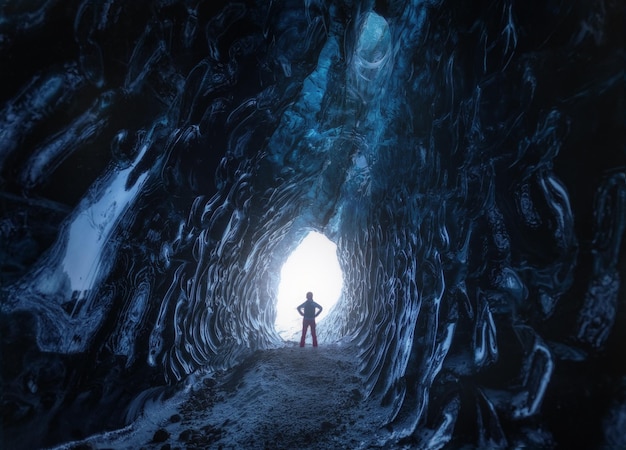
[0,0,626,448]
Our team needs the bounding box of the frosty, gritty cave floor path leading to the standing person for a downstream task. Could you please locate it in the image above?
[56,343,388,450]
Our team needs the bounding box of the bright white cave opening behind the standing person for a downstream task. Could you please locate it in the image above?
[275,232,343,340]
